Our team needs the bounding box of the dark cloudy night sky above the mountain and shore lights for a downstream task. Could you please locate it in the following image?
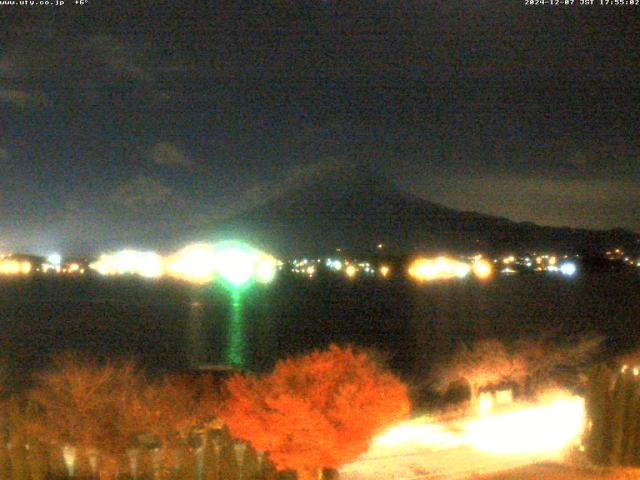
[0,0,640,253]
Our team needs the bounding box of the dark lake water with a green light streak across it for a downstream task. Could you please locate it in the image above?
[0,272,640,378]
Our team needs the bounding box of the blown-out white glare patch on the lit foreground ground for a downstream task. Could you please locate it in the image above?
[373,392,585,455]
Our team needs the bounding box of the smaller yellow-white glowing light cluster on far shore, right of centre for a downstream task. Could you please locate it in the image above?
[409,256,493,282]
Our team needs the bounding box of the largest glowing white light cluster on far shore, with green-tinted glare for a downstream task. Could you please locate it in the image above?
[90,243,278,286]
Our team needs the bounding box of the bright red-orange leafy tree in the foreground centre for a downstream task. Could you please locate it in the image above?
[221,345,410,480]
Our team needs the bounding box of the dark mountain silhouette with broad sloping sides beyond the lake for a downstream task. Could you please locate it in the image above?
[209,165,640,256]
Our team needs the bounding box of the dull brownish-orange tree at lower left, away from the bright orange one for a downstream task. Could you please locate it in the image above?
[29,354,141,480]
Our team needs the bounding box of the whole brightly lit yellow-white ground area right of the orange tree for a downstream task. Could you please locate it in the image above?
[340,397,584,480]
